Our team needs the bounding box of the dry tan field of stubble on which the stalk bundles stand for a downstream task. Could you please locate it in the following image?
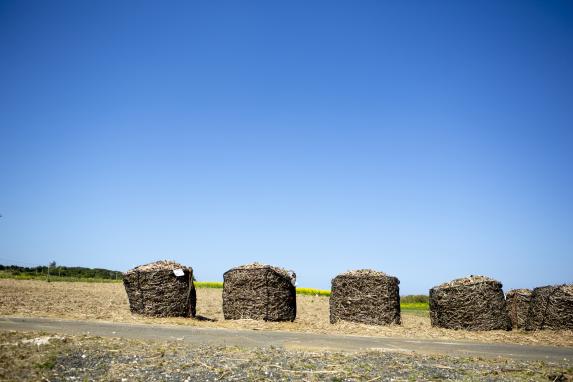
[0,279,573,346]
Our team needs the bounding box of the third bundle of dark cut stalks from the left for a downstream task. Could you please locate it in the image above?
[330,269,400,325]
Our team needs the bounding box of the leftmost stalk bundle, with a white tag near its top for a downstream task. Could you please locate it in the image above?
[123,260,197,317]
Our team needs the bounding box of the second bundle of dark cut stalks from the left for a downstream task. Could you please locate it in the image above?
[223,263,296,321]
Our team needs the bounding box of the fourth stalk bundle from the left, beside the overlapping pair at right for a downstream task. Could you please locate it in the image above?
[430,276,511,330]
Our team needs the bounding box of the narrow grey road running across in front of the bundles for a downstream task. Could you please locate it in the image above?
[0,317,573,364]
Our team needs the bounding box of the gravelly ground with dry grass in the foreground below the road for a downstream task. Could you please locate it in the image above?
[0,332,573,381]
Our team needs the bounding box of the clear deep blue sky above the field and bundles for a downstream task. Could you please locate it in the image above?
[0,0,573,294]
